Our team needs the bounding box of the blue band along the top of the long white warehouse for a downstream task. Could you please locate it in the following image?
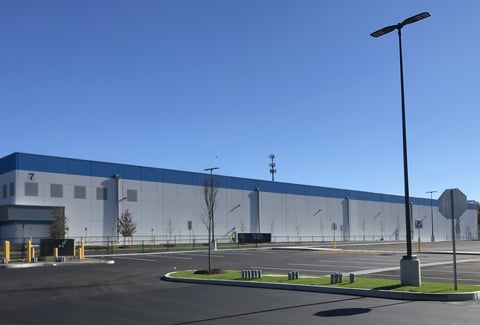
[0,152,476,209]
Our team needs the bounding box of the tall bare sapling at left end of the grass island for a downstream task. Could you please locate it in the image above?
[203,175,218,273]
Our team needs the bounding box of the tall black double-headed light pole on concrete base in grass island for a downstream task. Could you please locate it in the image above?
[370,12,430,285]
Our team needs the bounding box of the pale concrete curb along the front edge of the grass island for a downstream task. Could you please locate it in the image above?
[162,272,480,301]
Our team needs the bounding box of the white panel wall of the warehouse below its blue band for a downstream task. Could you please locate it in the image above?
[0,170,478,241]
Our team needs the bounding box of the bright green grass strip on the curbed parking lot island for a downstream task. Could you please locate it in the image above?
[170,270,480,293]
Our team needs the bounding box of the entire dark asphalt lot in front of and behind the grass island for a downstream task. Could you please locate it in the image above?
[0,242,480,325]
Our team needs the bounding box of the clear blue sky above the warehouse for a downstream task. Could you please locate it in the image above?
[0,0,480,200]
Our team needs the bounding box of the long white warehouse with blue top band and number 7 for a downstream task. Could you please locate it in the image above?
[0,153,478,241]
